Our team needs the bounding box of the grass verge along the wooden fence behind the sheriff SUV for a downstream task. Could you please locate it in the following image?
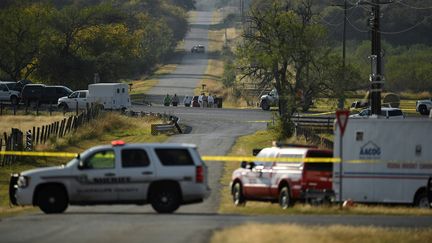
[0,112,167,215]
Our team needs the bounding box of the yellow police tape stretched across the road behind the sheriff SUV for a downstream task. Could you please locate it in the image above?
[0,151,379,163]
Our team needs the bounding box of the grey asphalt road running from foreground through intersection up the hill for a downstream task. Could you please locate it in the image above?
[0,7,432,243]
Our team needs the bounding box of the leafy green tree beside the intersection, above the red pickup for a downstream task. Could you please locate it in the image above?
[237,0,325,137]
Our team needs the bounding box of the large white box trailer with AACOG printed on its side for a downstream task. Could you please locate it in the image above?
[333,118,432,207]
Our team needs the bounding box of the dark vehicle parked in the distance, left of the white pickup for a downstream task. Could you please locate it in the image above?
[21,84,73,105]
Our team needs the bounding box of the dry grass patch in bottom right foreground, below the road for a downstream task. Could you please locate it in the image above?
[211,223,432,243]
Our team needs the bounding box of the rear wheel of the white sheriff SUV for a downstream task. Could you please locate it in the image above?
[150,187,181,213]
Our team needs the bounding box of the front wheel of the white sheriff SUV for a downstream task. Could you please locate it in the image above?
[37,185,68,214]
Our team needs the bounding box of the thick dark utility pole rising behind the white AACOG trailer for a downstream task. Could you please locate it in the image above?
[370,0,384,115]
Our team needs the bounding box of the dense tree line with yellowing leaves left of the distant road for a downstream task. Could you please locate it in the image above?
[0,0,195,89]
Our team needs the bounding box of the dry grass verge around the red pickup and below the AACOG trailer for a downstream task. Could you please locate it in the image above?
[219,130,432,216]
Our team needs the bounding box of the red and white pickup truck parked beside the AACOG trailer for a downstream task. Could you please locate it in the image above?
[231,147,334,209]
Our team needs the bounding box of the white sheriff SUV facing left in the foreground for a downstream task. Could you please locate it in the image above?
[9,141,210,213]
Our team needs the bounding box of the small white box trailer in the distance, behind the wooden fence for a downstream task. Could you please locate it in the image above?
[87,83,131,110]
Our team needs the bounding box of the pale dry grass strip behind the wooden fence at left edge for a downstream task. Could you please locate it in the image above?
[0,113,64,134]
